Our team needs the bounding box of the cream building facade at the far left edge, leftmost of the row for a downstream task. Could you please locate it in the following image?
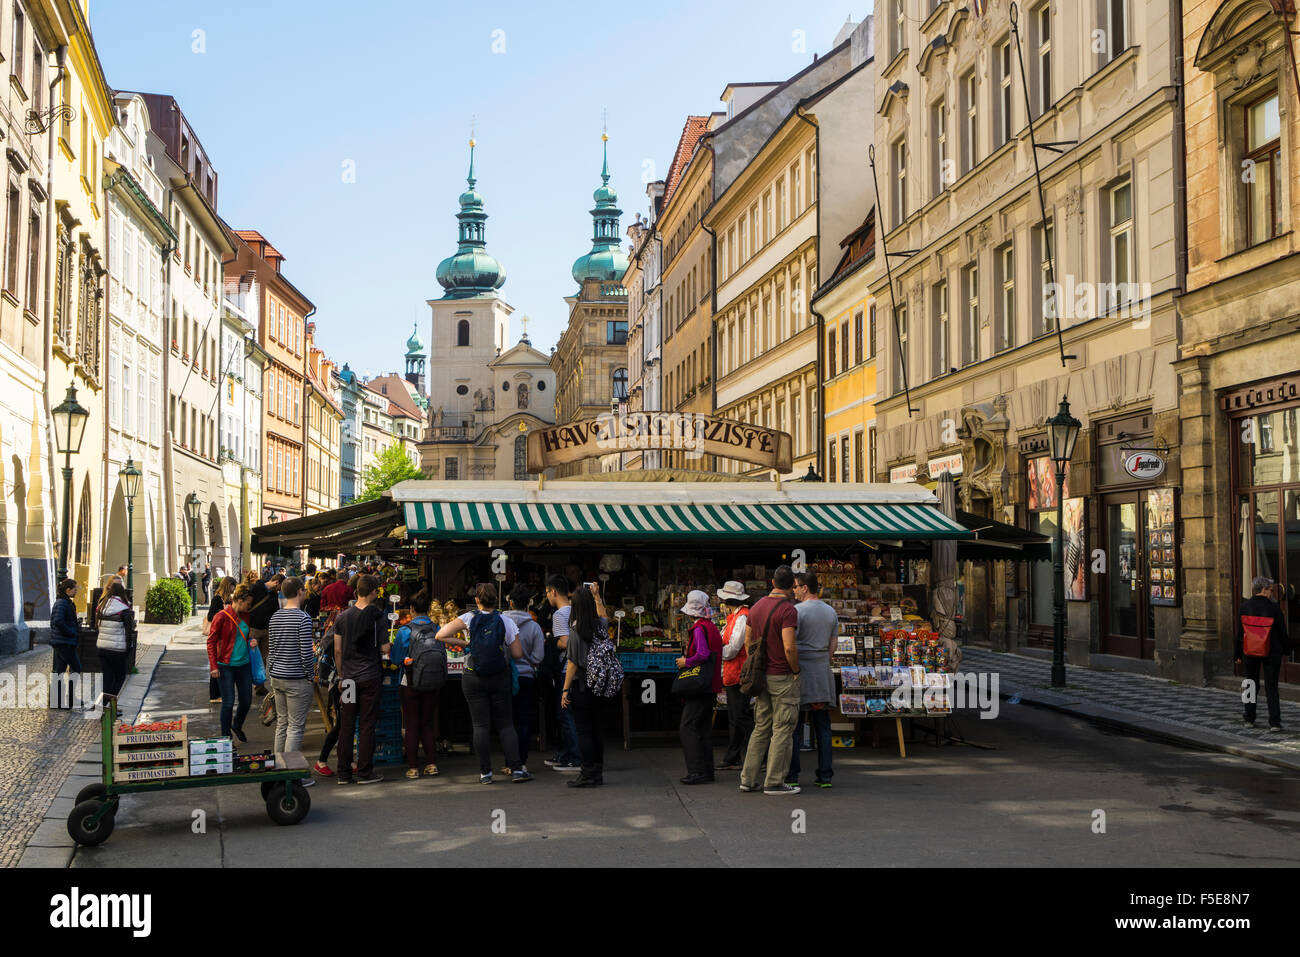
[0,0,66,655]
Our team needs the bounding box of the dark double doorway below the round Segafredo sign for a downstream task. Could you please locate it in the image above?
[1100,492,1156,661]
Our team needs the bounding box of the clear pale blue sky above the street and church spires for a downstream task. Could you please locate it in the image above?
[91,0,871,374]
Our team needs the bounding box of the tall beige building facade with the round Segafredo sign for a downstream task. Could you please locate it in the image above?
[870,0,1186,676]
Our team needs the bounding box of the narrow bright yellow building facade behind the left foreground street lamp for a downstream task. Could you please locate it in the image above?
[48,0,115,611]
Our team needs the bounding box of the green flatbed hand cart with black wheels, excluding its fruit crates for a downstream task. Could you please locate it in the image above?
[68,696,312,848]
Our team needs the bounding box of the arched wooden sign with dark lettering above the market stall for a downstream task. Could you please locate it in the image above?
[528,412,794,472]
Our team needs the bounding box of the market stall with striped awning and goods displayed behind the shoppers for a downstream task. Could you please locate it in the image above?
[390,480,975,746]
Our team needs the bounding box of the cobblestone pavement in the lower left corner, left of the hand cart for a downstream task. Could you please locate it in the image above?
[0,645,99,867]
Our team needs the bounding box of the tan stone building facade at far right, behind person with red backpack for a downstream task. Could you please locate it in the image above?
[1174,0,1300,683]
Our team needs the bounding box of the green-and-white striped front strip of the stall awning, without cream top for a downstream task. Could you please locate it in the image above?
[394,495,971,542]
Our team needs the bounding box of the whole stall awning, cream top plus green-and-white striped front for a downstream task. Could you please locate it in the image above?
[391,481,971,544]
